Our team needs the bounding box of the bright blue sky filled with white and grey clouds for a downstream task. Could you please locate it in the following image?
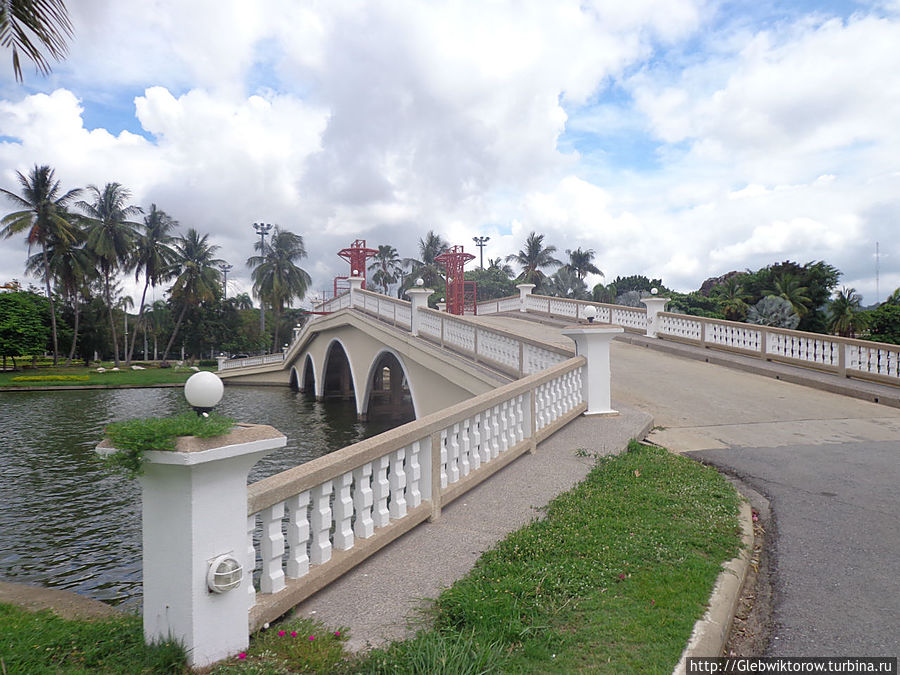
[0,0,900,305]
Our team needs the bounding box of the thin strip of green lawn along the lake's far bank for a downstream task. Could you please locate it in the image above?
[0,363,216,389]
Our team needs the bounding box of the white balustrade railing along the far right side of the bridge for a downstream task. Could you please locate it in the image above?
[478,295,900,385]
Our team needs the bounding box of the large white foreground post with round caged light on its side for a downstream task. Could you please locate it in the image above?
[110,425,287,668]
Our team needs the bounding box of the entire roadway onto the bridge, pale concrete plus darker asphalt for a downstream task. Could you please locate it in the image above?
[478,318,900,656]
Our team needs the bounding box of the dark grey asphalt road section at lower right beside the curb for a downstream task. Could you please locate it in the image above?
[686,441,900,656]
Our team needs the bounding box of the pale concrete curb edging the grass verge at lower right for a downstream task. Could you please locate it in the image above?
[672,497,753,675]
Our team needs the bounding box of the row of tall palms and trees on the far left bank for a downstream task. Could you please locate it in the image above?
[0,165,310,367]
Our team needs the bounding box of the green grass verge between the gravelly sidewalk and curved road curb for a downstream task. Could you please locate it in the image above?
[214,443,740,675]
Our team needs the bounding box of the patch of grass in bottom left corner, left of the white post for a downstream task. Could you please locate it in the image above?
[0,604,189,675]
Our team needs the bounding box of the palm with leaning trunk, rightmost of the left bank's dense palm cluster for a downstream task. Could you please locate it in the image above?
[163,228,223,361]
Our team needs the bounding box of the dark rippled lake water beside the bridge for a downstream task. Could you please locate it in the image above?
[0,387,398,606]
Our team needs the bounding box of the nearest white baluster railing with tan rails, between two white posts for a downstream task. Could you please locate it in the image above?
[247,357,587,630]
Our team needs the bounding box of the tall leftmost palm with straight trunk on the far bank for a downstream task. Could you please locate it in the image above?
[0,165,81,365]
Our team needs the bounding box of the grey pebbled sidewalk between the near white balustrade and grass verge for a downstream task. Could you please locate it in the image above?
[284,407,652,650]
